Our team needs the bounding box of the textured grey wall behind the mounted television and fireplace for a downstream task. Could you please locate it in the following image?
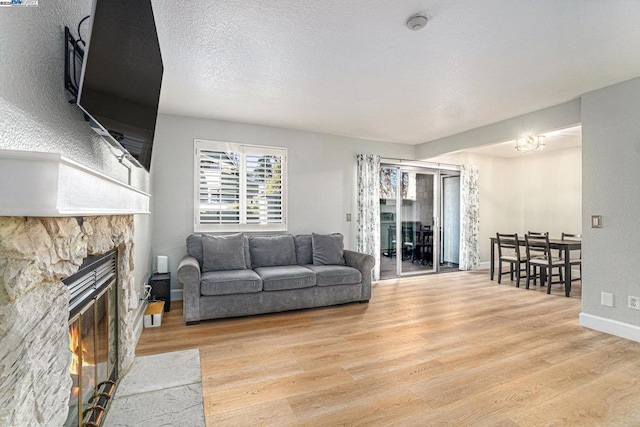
[0,0,151,300]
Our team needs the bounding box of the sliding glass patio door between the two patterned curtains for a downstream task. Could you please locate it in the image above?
[380,164,459,279]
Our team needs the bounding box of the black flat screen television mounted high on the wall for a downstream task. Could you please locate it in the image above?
[77,0,164,170]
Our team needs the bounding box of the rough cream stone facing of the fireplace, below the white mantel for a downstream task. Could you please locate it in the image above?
[0,215,140,426]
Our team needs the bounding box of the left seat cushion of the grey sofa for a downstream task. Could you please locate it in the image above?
[200,270,262,296]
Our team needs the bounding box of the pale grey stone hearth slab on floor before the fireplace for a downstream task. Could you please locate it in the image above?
[103,349,205,427]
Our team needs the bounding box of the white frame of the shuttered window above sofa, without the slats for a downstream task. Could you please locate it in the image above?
[193,139,288,233]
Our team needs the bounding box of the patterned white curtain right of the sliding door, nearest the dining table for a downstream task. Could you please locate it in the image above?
[460,165,480,270]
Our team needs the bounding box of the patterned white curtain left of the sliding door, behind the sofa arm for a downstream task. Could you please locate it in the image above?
[356,154,380,280]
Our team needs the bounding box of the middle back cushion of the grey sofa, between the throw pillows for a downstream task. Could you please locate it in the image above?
[249,234,297,268]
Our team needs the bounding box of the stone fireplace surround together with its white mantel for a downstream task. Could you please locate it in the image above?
[0,150,149,426]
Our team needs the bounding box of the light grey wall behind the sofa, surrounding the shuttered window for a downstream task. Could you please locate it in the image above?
[151,115,414,298]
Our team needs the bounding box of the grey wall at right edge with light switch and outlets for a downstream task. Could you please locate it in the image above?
[581,78,640,341]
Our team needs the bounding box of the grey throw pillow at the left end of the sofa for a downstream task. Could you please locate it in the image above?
[202,233,247,273]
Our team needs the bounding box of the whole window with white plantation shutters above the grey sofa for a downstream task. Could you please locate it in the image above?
[194,140,287,232]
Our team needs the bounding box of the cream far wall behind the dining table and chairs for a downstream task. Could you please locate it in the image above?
[429,148,582,263]
